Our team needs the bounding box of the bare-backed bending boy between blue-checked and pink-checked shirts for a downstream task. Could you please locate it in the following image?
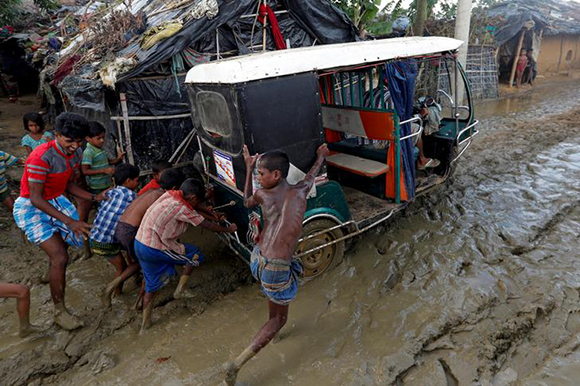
[114,169,185,309]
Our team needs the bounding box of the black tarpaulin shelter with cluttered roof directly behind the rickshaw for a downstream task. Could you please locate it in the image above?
[47,0,358,170]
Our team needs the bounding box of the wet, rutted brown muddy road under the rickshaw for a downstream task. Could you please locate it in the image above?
[0,81,580,386]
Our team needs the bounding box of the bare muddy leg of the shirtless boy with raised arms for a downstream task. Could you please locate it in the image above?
[224,300,288,386]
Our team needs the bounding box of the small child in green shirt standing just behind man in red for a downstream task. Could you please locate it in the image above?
[79,122,125,221]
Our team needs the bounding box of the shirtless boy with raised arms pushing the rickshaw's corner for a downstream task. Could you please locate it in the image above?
[225,144,328,386]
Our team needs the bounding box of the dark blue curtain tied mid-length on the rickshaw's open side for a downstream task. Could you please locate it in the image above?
[385,59,418,200]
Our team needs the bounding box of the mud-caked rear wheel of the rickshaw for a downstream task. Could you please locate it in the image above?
[296,219,344,279]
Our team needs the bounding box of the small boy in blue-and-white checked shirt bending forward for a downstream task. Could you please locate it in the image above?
[89,164,139,307]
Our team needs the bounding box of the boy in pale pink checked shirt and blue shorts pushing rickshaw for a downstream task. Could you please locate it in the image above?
[135,178,237,332]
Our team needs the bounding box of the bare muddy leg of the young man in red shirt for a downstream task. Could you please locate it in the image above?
[40,233,82,330]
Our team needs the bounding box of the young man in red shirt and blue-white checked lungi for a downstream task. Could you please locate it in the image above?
[13,113,110,330]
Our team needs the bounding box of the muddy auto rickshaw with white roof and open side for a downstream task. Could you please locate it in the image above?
[186,37,478,277]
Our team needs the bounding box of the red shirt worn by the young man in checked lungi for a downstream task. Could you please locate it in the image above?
[20,141,83,200]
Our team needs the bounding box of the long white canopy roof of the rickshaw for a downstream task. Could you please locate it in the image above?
[185,37,463,84]
